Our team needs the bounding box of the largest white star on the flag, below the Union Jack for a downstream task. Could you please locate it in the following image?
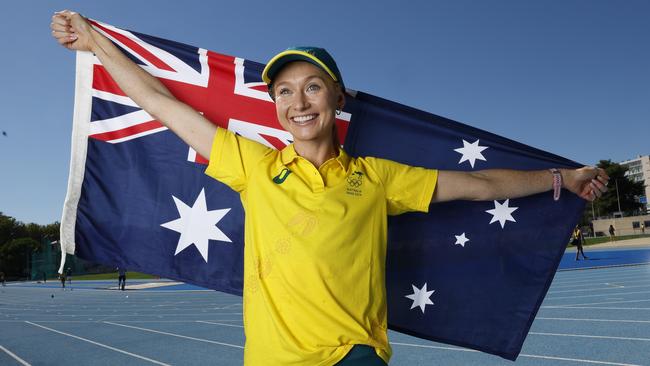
[160,189,232,263]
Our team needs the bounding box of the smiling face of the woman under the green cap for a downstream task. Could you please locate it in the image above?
[273,61,345,144]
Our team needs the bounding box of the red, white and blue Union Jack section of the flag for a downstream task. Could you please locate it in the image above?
[89,21,350,163]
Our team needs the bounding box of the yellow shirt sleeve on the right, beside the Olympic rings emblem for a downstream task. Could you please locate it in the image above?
[366,158,438,215]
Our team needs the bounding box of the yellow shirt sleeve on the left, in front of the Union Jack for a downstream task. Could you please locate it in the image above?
[205,128,273,192]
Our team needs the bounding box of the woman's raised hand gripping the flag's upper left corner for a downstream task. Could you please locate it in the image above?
[50,10,93,51]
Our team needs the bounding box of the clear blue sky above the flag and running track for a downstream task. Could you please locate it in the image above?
[0,0,650,224]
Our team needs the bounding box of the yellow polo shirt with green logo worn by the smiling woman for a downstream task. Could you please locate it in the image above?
[206,128,438,366]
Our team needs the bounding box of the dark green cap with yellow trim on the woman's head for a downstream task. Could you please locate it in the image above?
[262,47,345,96]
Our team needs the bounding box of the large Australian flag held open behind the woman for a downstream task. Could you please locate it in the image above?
[61,21,584,360]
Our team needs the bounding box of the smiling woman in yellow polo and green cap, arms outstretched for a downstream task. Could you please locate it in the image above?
[51,11,608,365]
